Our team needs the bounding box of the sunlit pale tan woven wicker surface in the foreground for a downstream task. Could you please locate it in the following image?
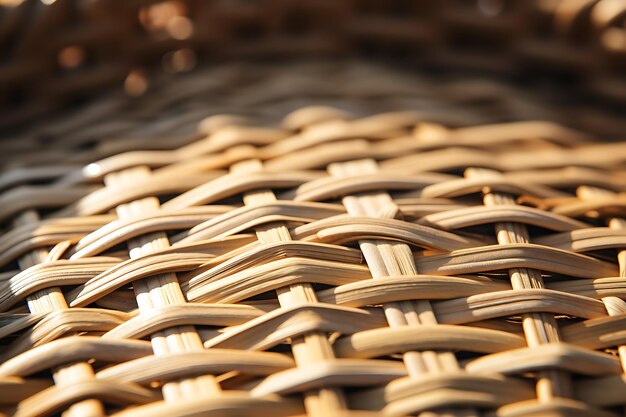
[0,56,626,417]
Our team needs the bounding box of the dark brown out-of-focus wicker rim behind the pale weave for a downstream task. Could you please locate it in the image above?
[0,0,626,126]
